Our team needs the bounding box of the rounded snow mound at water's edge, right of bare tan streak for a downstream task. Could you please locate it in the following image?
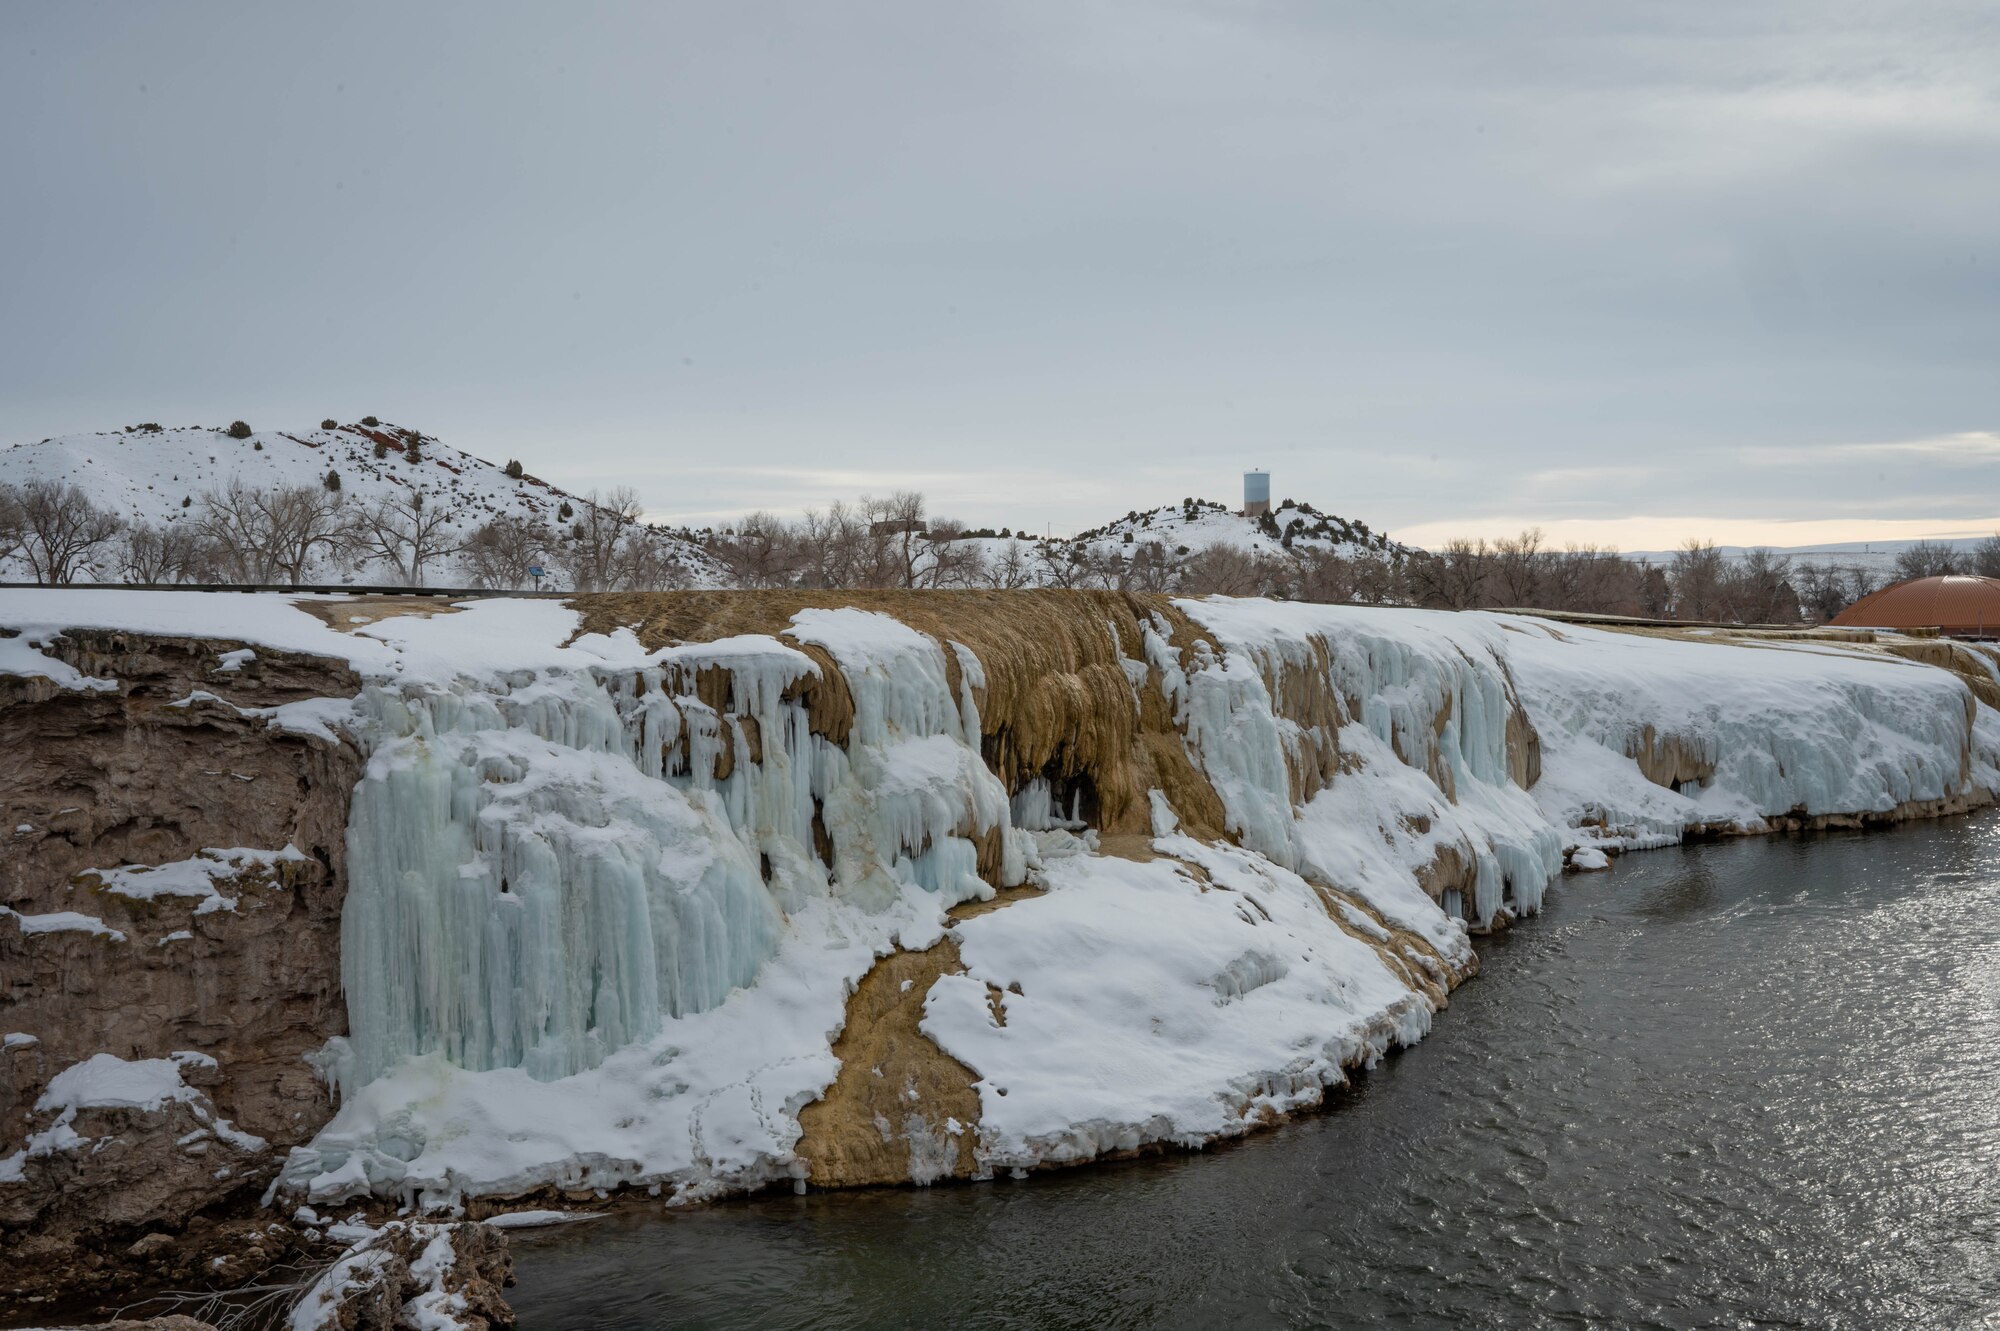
[922,835,1432,1169]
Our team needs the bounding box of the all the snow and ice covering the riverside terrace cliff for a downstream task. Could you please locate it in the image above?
[0,590,2000,1207]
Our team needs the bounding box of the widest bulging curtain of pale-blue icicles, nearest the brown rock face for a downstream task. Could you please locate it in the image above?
[336,675,782,1091]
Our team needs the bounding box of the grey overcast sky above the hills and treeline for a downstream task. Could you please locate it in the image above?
[0,0,2000,550]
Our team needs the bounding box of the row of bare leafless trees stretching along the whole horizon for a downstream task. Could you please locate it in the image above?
[0,474,2000,624]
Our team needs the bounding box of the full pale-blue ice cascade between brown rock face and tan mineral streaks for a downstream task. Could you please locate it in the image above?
[330,612,1026,1093]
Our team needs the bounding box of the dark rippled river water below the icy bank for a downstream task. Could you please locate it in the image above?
[512,815,2000,1331]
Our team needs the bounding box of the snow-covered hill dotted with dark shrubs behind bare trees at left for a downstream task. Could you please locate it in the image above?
[0,418,722,588]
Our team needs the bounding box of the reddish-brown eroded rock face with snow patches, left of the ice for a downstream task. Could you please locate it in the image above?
[0,632,360,1315]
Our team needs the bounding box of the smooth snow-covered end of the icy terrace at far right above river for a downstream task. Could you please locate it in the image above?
[1504,616,2000,849]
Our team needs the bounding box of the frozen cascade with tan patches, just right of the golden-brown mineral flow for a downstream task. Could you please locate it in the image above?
[1146,600,1562,927]
